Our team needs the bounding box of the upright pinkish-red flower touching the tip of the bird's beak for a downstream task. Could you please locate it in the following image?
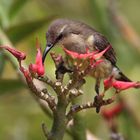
[29,40,45,76]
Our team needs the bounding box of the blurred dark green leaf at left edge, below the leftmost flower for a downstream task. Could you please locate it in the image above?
[0,79,25,95]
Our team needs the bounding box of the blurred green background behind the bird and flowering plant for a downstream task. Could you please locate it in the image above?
[0,0,140,140]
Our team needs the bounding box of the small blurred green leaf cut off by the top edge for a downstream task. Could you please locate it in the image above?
[9,0,28,19]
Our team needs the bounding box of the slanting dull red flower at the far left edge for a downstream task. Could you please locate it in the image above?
[0,46,26,61]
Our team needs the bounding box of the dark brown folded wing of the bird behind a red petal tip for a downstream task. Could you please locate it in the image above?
[94,32,117,65]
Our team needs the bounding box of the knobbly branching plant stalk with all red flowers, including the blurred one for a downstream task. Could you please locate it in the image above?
[0,40,140,140]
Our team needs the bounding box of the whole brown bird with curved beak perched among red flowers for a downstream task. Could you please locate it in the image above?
[42,19,131,94]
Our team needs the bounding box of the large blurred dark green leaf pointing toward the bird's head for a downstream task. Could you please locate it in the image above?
[6,17,54,43]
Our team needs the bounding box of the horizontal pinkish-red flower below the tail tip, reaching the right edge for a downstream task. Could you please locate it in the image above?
[112,81,140,90]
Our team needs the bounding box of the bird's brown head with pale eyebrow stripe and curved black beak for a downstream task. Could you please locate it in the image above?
[42,19,71,63]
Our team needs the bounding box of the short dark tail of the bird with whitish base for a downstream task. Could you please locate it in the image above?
[113,66,132,82]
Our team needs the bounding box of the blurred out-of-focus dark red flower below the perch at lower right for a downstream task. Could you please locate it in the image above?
[102,103,124,120]
